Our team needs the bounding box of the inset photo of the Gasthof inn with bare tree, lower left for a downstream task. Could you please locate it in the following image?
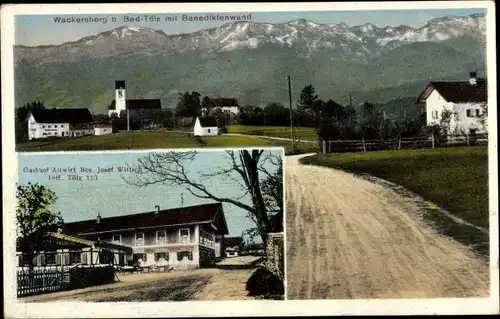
[11,148,285,303]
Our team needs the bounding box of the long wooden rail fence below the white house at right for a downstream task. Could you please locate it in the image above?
[320,134,488,154]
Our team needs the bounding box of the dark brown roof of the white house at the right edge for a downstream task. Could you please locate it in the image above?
[417,79,487,103]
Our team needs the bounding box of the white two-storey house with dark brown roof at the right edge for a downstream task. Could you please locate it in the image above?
[417,72,487,133]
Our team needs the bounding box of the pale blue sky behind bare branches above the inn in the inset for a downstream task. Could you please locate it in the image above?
[18,150,281,242]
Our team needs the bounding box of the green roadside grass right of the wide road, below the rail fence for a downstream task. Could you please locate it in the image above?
[301,146,489,255]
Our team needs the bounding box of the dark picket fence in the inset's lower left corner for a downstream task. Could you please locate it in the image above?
[17,266,115,297]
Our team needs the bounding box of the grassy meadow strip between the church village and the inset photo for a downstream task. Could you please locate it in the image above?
[16,131,317,153]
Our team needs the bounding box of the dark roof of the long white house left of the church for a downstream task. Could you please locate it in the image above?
[28,108,92,124]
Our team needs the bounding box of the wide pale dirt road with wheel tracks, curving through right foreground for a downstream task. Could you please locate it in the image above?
[285,155,489,299]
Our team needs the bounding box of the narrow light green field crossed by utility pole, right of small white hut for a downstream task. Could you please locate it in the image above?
[227,125,318,141]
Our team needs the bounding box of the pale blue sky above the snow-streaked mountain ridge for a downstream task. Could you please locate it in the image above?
[15,9,486,46]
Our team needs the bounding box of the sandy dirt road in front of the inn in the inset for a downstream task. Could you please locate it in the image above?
[20,268,254,302]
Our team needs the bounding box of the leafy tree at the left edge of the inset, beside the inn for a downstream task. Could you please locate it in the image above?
[16,183,64,269]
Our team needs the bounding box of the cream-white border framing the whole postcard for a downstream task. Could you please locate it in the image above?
[1,1,499,318]
